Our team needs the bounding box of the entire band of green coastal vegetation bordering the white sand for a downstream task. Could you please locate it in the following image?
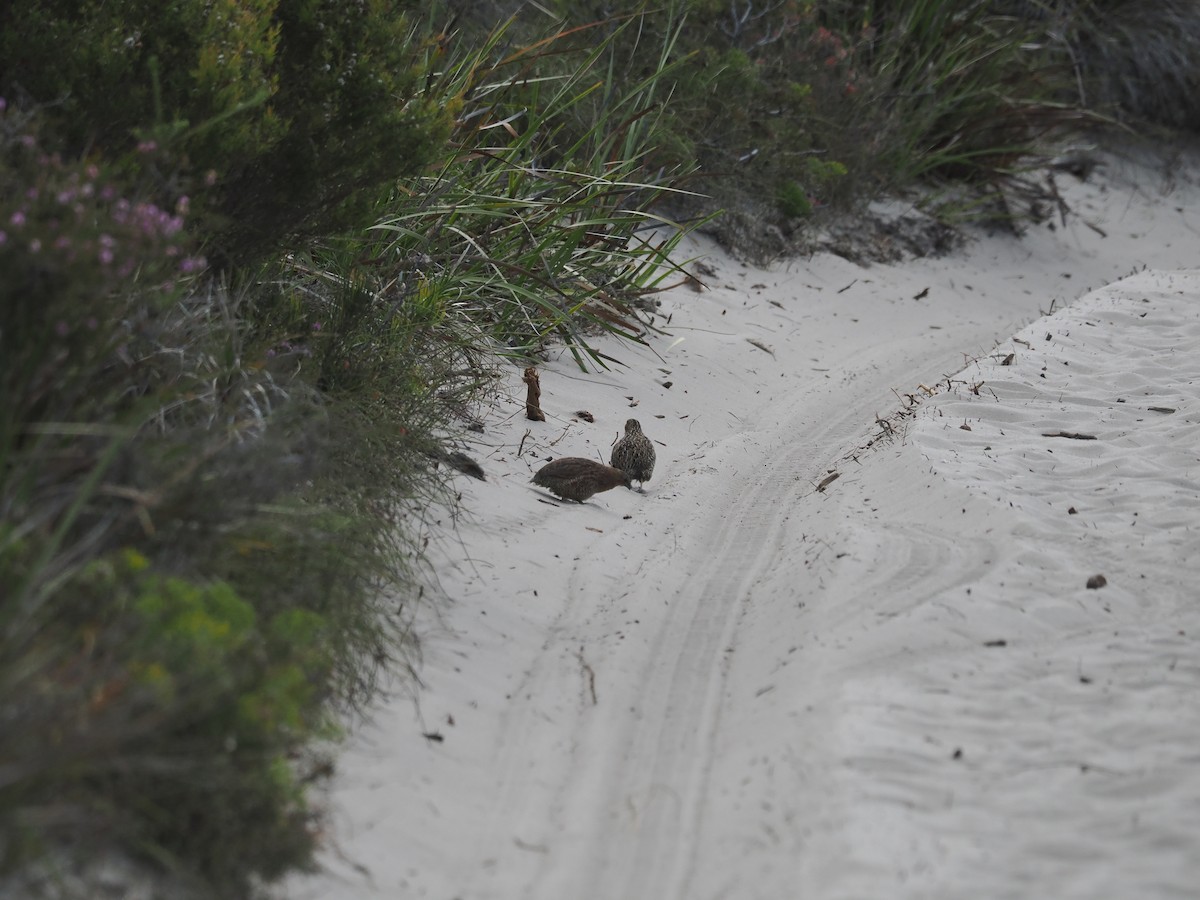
[0,0,1200,898]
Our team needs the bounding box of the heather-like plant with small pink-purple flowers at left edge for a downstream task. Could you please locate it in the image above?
[0,107,205,445]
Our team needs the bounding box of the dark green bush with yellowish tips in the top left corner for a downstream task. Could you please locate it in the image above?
[0,0,454,265]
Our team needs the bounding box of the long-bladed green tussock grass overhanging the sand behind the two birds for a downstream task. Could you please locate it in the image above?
[367,11,686,366]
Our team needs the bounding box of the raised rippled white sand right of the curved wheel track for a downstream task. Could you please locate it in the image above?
[839,272,1200,898]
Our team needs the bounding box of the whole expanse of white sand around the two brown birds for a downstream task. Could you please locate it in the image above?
[282,150,1200,900]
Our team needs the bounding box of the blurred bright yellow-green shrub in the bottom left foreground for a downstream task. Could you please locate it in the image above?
[0,551,330,895]
